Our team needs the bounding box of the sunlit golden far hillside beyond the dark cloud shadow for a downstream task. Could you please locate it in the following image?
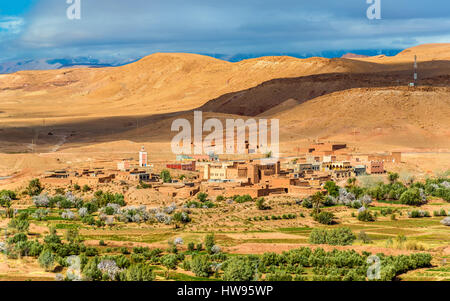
[0,54,379,119]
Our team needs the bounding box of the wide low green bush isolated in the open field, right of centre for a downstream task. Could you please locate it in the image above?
[309,228,356,246]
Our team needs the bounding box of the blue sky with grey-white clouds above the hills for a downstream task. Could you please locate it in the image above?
[0,0,450,62]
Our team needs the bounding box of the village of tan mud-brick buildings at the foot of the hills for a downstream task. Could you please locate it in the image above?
[41,143,402,198]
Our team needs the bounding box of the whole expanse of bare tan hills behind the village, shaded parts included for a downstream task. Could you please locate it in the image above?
[0,44,450,168]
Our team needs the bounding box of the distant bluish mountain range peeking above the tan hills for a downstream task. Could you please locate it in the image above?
[0,49,401,74]
